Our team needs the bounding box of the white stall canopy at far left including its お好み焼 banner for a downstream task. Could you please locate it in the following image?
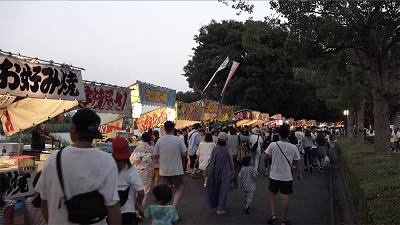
[0,51,85,136]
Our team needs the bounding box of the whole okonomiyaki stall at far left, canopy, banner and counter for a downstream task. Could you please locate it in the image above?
[0,50,85,199]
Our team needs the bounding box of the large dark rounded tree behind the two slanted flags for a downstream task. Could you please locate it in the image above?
[184,20,340,120]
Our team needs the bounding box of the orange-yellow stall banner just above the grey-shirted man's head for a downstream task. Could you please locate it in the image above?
[136,107,168,133]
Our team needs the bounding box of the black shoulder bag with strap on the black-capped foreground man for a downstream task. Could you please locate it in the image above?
[56,150,107,224]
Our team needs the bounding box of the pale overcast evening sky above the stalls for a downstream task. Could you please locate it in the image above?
[0,0,273,91]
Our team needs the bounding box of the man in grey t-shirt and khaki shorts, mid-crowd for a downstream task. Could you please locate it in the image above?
[153,121,187,208]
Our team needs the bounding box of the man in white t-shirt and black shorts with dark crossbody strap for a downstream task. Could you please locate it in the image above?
[264,126,303,224]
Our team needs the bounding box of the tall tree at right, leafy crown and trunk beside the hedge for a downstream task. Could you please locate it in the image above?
[271,0,400,154]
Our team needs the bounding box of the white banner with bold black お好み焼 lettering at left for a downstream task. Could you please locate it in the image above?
[0,55,85,101]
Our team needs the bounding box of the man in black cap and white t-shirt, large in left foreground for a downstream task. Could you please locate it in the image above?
[35,109,121,224]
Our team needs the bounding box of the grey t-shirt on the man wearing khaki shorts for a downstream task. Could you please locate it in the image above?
[153,135,187,176]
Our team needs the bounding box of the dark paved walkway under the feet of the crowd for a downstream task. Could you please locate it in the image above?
[140,150,340,224]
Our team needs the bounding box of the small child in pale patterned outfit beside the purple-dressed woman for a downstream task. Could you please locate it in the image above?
[238,156,258,214]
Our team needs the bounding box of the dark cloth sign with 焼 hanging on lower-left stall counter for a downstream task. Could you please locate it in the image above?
[2,165,37,199]
